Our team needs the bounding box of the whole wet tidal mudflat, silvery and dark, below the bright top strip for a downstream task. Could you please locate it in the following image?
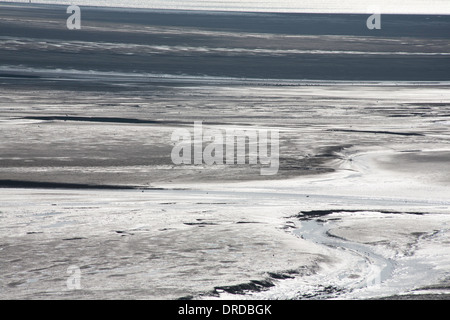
[0,5,450,299]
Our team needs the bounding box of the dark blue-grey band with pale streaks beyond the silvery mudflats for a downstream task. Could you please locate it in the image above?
[0,4,450,81]
